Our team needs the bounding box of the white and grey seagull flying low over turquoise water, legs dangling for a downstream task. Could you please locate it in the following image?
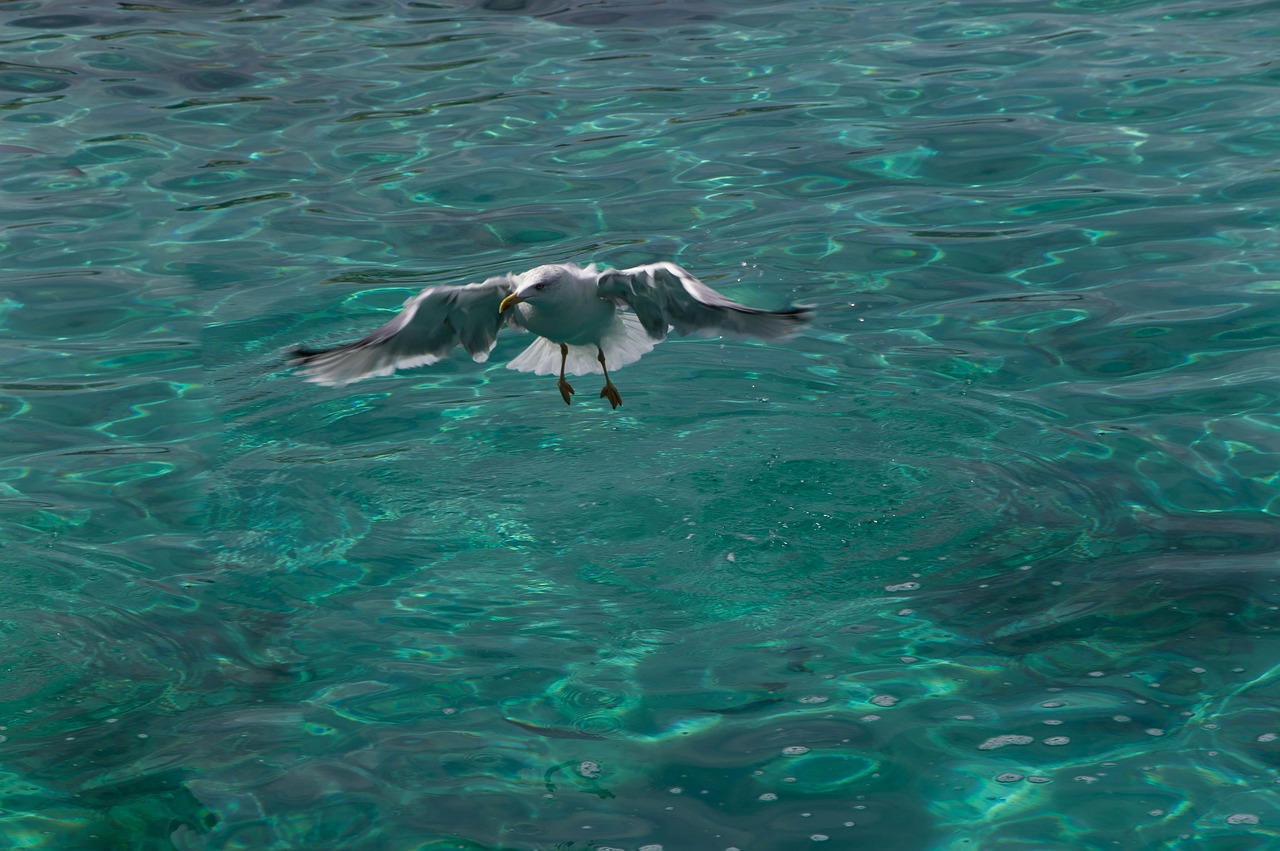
[289,262,813,408]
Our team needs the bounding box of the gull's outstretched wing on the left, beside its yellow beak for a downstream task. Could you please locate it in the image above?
[289,275,517,386]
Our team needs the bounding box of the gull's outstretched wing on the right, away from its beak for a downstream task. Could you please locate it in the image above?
[598,262,813,340]
